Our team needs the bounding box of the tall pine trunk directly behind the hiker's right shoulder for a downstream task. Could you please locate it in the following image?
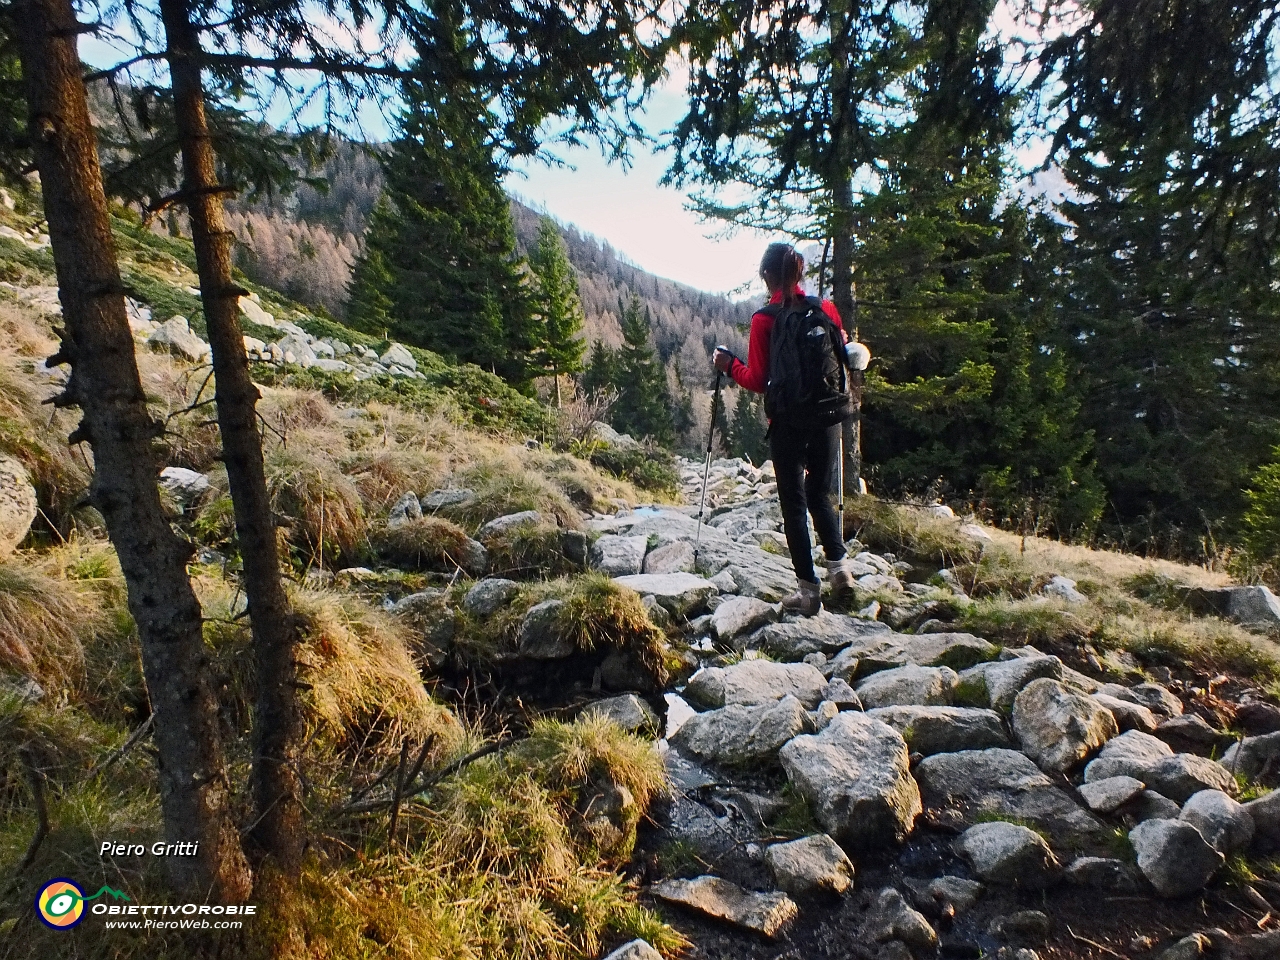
[827,0,863,497]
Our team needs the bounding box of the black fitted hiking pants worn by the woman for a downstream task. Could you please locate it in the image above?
[769,424,845,584]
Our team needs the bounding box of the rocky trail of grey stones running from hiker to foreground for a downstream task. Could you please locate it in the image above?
[563,461,1280,960]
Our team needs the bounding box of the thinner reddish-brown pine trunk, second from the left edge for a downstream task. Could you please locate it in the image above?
[160,0,303,874]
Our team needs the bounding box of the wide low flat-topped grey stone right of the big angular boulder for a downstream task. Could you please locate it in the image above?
[915,748,1106,844]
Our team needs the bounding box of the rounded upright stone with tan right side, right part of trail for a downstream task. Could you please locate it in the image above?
[1012,677,1120,773]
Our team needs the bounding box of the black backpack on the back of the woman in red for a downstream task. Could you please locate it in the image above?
[760,297,854,428]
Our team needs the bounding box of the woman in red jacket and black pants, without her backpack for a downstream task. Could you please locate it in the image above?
[713,243,854,617]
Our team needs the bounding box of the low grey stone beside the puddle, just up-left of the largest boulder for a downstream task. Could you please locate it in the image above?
[671,696,809,765]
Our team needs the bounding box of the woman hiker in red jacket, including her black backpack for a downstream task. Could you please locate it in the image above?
[713,243,854,617]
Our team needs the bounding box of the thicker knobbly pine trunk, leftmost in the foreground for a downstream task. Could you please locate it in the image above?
[12,0,251,902]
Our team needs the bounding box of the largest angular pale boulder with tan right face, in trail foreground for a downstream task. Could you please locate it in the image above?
[778,712,920,849]
